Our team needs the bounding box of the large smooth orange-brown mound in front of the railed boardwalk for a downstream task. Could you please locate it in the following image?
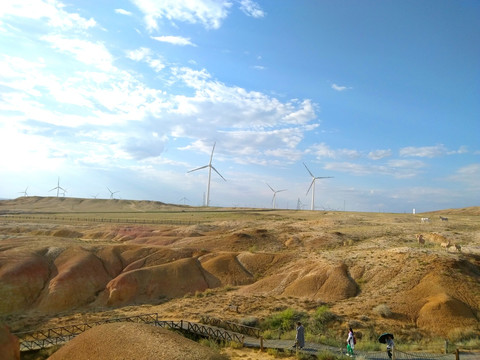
[48,323,225,360]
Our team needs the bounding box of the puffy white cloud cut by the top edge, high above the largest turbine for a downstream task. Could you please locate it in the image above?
[132,0,232,30]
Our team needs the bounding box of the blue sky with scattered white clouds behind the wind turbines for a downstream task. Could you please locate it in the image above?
[0,0,480,212]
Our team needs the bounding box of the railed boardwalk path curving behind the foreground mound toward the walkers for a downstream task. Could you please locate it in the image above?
[15,313,472,360]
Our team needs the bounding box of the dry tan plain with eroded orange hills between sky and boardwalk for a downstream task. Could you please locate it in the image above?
[0,197,480,360]
